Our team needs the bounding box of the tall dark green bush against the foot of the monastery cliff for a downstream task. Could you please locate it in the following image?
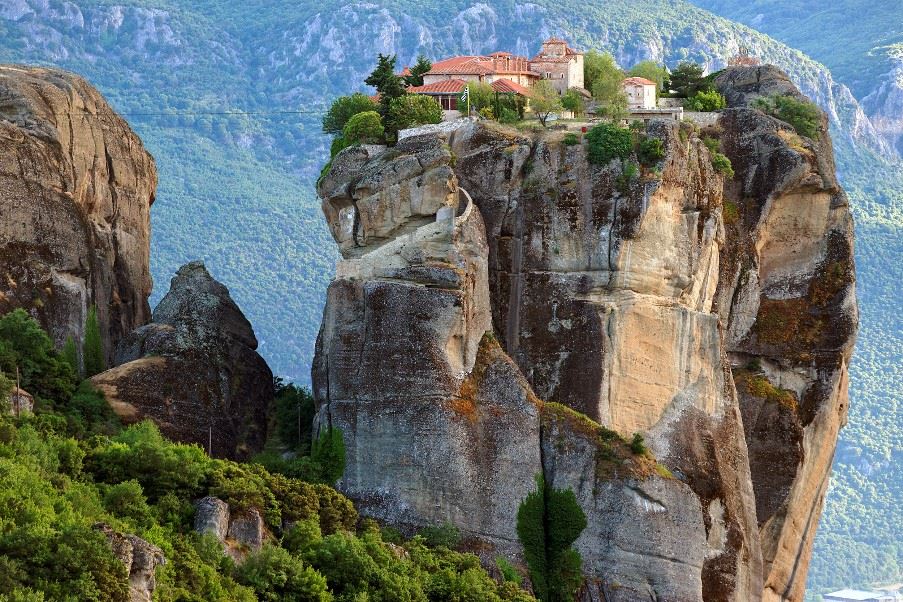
[517,475,586,602]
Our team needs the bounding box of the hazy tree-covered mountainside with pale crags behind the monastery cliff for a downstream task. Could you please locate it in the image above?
[0,0,903,589]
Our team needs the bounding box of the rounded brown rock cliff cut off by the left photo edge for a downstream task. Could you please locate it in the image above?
[0,66,157,361]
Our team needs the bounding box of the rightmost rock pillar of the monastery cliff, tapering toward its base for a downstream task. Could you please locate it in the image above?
[716,66,858,600]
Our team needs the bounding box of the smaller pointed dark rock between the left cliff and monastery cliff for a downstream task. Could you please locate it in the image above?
[92,262,273,458]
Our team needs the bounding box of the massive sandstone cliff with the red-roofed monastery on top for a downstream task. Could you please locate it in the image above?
[313,67,857,602]
